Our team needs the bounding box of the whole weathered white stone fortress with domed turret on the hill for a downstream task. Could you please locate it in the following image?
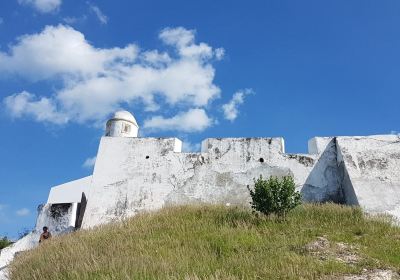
[0,111,400,279]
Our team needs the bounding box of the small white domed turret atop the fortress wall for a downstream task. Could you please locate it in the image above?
[106,111,139,137]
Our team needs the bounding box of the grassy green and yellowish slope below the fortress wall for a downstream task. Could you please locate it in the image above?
[11,204,400,280]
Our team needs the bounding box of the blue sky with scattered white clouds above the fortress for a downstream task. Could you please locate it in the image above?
[0,0,400,237]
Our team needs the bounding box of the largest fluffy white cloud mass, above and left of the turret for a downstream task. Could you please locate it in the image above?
[0,25,224,132]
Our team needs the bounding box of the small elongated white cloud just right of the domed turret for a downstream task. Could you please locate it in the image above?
[144,108,212,132]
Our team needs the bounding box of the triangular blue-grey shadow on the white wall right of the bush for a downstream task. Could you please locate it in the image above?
[301,138,346,204]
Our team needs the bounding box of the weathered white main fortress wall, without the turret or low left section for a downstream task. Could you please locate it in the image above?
[79,135,400,227]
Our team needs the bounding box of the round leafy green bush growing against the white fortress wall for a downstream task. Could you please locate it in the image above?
[247,175,301,217]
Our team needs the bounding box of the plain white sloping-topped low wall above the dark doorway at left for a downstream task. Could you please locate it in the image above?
[47,176,92,204]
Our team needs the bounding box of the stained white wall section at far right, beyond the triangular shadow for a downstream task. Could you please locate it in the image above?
[336,135,400,217]
